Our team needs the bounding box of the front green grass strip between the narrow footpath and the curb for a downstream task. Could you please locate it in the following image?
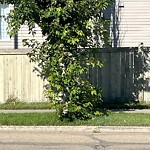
[0,113,150,126]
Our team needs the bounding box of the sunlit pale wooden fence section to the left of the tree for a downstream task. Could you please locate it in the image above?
[0,50,46,103]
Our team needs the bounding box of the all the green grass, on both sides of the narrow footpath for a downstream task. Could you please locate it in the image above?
[0,101,150,126]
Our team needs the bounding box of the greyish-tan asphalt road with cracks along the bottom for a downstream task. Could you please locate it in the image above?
[0,130,150,150]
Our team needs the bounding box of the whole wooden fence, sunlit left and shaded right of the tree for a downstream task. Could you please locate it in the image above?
[0,48,150,103]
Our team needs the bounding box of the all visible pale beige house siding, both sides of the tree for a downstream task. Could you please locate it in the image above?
[0,0,150,49]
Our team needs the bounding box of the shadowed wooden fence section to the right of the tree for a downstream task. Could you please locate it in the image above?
[90,48,150,103]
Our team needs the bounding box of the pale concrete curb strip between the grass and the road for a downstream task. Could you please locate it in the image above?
[0,126,150,133]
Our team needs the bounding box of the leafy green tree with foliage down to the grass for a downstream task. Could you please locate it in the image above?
[0,0,110,119]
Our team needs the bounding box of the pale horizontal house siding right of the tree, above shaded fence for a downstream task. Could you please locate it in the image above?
[116,0,150,47]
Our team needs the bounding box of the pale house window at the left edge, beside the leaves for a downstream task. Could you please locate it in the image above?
[0,4,10,40]
